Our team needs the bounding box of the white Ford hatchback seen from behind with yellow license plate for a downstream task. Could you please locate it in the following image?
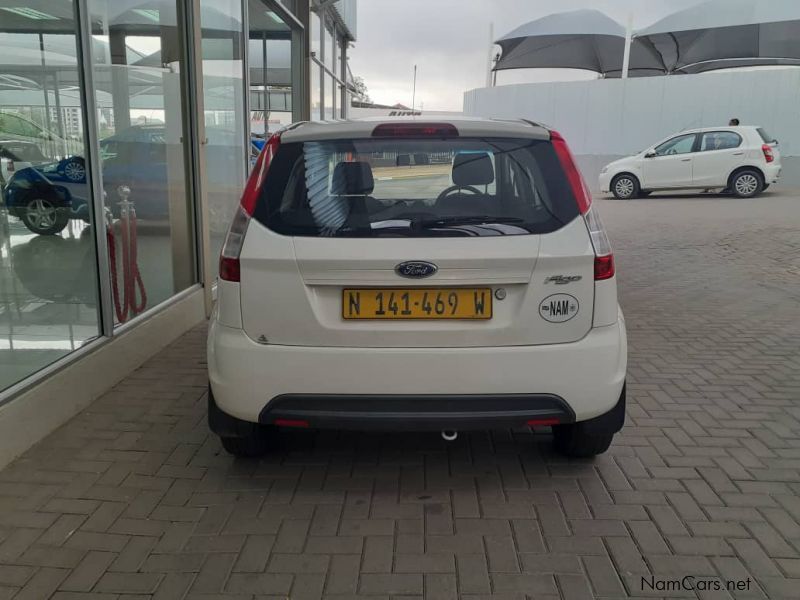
[208,119,627,456]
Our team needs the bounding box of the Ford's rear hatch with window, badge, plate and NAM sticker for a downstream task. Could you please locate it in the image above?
[221,120,613,348]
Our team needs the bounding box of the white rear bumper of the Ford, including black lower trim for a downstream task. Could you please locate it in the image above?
[208,313,627,429]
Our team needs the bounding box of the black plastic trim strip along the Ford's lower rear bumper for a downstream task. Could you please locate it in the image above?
[259,394,575,431]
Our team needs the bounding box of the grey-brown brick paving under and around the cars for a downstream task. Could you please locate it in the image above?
[0,194,800,600]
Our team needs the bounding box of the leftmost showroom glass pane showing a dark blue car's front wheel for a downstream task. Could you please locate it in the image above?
[0,0,101,391]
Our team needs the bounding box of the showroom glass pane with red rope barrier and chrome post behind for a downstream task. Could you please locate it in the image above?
[88,0,197,323]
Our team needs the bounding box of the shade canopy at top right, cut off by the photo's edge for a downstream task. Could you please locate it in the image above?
[634,0,800,73]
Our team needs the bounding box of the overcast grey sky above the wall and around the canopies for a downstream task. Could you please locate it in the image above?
[350,0,701,110]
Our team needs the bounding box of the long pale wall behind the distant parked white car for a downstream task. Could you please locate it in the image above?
[464,68,800,187]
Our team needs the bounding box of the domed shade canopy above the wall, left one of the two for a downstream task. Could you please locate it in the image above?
[494,9,665,77]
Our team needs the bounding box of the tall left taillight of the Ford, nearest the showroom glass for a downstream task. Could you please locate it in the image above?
[219,133,281,282]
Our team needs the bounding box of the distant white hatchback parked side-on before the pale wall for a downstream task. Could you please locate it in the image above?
[600,126,781,200]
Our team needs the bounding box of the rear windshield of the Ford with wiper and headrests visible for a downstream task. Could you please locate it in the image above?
[254,138,578,237]
